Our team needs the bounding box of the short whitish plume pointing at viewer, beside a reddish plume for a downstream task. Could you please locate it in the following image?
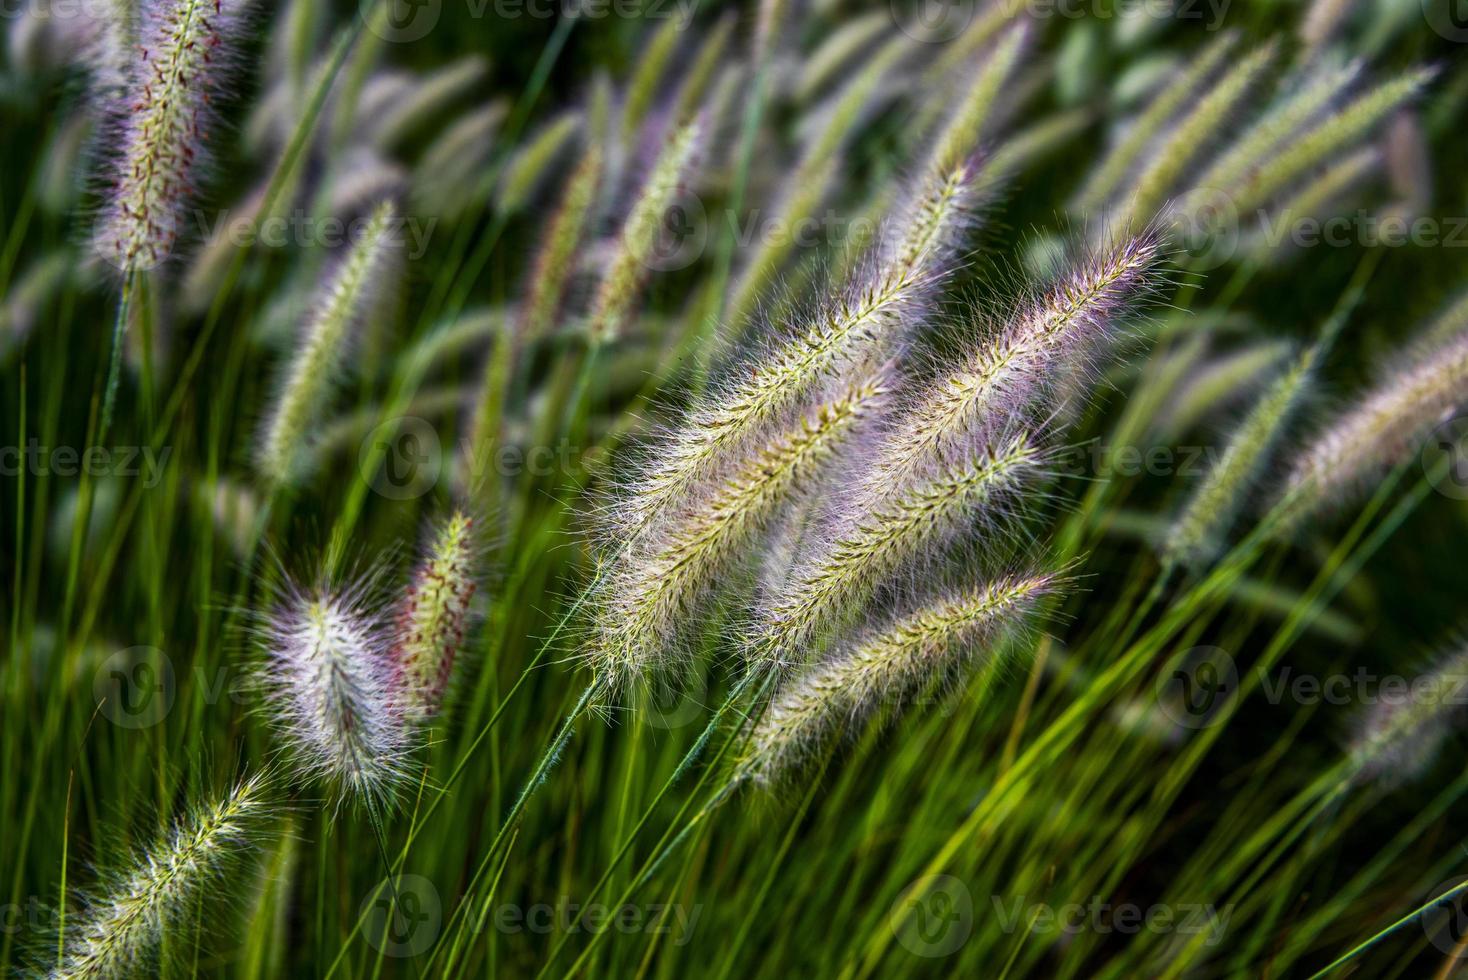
[258,585,413,811]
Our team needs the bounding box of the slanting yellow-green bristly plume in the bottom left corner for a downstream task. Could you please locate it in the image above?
[50,773,275,980]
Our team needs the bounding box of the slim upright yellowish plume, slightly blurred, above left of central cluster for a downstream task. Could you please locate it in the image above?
[587,120,703,346]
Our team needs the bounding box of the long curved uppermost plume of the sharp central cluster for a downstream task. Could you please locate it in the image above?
[617,154,978,533]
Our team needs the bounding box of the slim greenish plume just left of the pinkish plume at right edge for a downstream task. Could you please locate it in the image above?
[1163,348,1317,568]
